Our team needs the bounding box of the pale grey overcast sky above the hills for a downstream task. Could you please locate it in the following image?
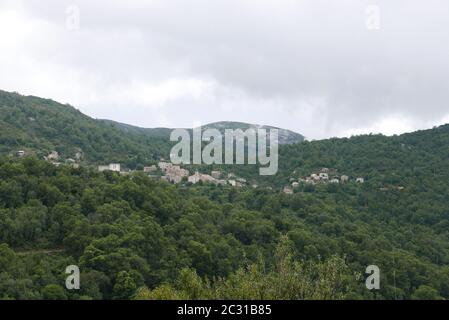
[0,0,449,139]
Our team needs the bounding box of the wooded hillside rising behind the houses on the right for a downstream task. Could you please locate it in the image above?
[222,125,449,190]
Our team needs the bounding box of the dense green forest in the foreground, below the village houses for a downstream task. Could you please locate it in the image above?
[0,157,449,299]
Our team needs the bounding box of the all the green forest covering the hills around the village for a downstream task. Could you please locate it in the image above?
[0,91,449,299]
